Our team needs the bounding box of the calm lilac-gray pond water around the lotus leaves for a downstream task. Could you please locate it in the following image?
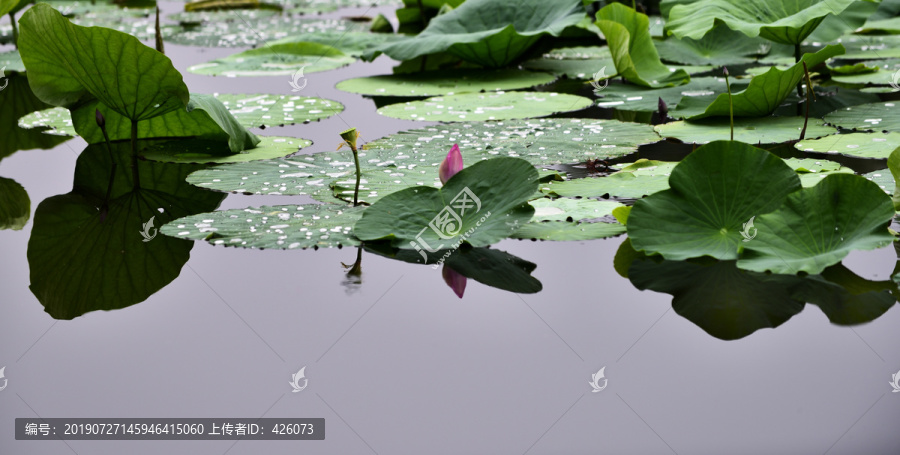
[0,3,900,455]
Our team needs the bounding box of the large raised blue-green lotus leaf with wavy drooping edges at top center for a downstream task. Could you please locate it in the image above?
[364,0,584,68]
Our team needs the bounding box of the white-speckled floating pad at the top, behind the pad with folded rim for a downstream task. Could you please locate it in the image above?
[162,15,377,48]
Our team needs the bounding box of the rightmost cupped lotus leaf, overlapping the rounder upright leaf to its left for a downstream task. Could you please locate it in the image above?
[736,174,894,274]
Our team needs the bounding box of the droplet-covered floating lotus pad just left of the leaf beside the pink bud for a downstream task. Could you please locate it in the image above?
[159,204,365,250]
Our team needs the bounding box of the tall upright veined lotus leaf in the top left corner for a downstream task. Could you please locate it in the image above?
[19,3,190,122]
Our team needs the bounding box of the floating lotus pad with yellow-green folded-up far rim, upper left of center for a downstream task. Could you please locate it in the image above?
[188,42,356,77]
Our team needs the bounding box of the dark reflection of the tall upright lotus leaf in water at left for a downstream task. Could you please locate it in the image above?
[28,142,223,319]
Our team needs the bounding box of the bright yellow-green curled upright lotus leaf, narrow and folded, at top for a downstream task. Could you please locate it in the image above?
[596,3,691,88]
